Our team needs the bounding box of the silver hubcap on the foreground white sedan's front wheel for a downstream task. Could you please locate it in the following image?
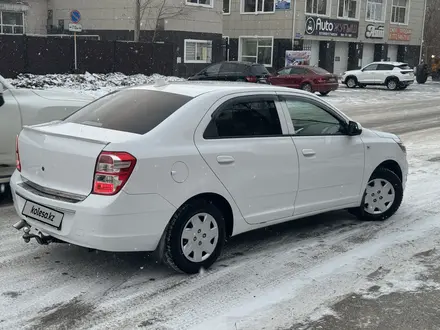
[364,179,396,214]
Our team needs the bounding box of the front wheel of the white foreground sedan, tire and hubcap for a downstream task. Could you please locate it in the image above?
[349,167,403,221]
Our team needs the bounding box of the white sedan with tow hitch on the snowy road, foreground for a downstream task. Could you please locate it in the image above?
[11,82,408,273]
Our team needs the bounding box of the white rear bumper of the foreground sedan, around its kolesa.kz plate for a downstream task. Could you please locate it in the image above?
[11,172,176,252]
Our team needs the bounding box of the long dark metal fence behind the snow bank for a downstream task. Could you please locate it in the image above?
[0,35,176,78]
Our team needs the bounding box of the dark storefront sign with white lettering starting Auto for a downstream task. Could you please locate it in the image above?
[305,16,359,38]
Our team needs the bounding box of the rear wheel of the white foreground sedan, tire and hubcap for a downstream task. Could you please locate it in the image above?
[163,199,226,274]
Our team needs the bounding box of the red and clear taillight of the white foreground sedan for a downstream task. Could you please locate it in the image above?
[93,151,136,195]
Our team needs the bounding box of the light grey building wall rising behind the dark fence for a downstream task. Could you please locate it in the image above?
[0,0,224,76]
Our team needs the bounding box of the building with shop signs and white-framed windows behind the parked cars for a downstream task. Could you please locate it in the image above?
[223,0,425,74]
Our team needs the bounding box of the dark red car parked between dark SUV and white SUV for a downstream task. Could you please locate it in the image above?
[268,65,339,95]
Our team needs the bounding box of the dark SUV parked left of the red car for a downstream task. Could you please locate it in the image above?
[188,61,270,84]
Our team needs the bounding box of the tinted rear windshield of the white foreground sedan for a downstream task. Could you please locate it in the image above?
[64,89,192,134]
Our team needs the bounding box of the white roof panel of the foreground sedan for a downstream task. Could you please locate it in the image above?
[128,81,310,97]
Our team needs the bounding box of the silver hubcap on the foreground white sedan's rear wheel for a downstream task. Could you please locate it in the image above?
[180,213,219,262]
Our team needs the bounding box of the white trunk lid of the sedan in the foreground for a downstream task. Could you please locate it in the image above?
[18,122,139,196]
